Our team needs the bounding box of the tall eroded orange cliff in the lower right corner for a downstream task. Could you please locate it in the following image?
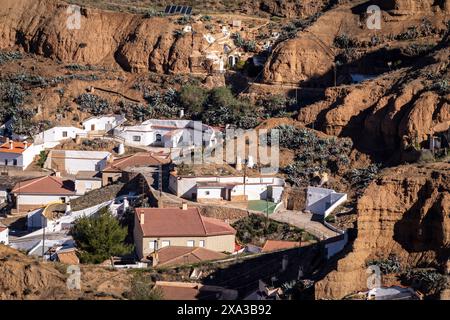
[315,163,450,299]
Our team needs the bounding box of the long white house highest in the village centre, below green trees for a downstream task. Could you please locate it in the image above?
[114,119,217,148]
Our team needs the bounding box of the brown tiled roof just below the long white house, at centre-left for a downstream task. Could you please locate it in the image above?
[103,152,170,171]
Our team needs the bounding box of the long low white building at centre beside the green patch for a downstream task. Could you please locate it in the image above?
[169,172,285,203]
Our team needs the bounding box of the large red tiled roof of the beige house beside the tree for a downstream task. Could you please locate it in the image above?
[136,208,236,237]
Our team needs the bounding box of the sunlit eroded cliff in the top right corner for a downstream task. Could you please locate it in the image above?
[263,0,450,87]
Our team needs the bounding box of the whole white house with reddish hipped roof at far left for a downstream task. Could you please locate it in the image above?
[11,176,77,212]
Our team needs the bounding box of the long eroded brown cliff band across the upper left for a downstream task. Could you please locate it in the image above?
[0,0,214,73]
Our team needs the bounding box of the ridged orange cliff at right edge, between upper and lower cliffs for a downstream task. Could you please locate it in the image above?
[298,44,450,159]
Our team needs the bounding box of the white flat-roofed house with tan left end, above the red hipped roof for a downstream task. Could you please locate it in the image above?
[44,150,112,174]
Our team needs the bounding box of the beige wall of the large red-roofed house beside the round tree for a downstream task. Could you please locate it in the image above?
[137,232,235,257]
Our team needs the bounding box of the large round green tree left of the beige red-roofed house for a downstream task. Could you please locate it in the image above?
[70,208,133,263]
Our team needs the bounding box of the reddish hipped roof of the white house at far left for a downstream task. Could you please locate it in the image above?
[11,176,75,195]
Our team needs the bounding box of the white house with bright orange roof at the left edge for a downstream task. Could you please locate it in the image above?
[0,140,41,170]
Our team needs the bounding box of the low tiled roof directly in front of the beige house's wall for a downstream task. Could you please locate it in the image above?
[158,246,227,266]
